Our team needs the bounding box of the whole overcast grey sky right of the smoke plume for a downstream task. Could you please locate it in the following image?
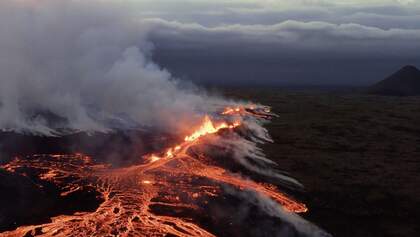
[124,0,420,85]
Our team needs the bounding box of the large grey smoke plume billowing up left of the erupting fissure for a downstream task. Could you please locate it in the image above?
[0,0,226,135]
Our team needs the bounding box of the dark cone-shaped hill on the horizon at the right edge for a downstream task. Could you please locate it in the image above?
[368,66,420,96]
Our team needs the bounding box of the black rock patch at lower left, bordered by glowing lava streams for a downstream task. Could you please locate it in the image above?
[0,168,103,231]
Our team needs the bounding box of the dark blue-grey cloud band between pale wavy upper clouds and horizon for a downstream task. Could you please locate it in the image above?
[145,19,420,85]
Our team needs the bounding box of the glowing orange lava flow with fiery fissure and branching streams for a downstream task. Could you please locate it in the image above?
[0,106,307,236]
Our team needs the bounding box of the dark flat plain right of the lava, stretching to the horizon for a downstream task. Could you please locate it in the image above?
[221,89,420,237]
